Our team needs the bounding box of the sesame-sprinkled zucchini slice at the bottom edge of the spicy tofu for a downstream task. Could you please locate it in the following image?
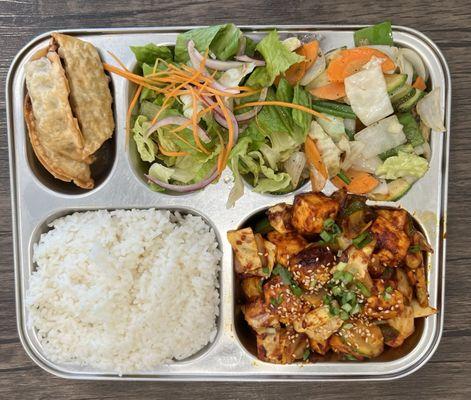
[329,321,384,360]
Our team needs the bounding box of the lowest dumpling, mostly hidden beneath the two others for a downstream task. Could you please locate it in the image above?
[24,95,94,189]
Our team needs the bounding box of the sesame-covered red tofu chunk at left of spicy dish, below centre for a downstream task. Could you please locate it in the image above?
[263,276,309,324]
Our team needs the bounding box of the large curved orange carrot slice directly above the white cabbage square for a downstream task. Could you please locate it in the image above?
[327,47,396,82]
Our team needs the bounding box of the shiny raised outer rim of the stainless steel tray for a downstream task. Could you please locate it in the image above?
[5,24,452,382]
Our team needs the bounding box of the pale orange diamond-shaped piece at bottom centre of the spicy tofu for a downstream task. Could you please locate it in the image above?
[294,306,343,342]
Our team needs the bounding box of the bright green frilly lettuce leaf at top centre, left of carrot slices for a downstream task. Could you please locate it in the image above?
[247,30,304,87]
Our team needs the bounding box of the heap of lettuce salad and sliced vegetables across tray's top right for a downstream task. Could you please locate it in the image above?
[105,22,444,207]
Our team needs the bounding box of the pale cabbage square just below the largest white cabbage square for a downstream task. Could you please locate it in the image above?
[355,115,407,159]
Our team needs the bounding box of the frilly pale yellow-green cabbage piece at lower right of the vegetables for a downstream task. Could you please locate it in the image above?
[376,151,428,180]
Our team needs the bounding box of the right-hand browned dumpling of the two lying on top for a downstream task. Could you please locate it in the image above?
[52,33,114,155]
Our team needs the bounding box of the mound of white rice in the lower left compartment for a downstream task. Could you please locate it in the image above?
[27,209,221,374]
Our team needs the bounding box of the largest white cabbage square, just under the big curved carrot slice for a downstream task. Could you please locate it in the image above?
[345,60,394,126]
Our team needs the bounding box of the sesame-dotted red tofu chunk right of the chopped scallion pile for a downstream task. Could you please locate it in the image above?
[363,279,404,320]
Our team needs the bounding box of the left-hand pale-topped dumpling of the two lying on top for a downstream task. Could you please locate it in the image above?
[25,52,87,160]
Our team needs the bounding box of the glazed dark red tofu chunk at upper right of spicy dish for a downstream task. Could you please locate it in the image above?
[371,210,410,267]
